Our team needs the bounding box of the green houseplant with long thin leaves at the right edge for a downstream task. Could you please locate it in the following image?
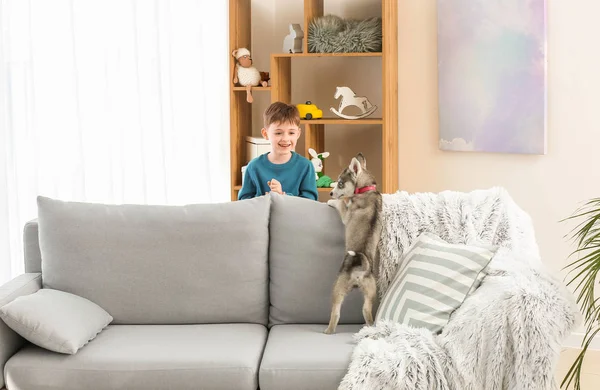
[560,198,600,390]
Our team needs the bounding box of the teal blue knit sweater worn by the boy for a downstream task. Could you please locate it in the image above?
[238,152,319,200]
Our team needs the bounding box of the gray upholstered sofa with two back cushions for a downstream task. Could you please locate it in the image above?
[0,196,376,390]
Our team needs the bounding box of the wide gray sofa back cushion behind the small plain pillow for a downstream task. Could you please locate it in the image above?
[38,197,270,324]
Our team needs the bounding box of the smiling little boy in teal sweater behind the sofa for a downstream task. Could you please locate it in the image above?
[238,102,319,200]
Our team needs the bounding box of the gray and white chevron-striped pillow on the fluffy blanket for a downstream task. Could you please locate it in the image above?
[375,233,497,333]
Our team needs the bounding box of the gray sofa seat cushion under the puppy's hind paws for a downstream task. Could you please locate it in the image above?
[259,324,363,390]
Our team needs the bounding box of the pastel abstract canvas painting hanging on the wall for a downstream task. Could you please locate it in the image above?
[437,0,547,154]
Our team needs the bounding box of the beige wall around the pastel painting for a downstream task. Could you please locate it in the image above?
[398,0,600,278]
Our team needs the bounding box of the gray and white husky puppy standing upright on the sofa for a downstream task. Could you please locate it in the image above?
[325,153,382,334]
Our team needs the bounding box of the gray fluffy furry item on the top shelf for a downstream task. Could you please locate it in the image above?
[308,15,382,53]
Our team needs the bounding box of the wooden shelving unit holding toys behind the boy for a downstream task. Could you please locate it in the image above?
[229,0,398,200]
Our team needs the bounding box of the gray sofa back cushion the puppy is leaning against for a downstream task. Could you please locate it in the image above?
[269,194,375,329]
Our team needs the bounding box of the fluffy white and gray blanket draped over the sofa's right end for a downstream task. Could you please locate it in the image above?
[339,188,580,390]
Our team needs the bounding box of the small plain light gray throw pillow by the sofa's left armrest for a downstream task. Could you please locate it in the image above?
[0,288,113,354]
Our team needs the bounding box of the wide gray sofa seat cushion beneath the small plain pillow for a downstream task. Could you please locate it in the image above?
[4,324,267,390]
